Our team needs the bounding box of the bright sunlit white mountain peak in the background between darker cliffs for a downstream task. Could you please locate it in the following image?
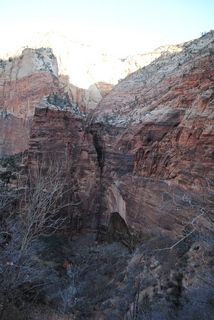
[2,32,177,112]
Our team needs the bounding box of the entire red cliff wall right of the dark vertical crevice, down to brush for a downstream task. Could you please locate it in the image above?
[86,32,214,233]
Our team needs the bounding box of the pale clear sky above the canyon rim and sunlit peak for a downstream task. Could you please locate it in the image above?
[0,0,214,57]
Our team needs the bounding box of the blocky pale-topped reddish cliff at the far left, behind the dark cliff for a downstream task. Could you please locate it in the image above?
[0,49,59,154]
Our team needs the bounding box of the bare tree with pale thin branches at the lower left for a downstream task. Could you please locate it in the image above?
[0,163,80,319]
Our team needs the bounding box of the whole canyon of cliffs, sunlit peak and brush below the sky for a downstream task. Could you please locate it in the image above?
[0,31,214,320]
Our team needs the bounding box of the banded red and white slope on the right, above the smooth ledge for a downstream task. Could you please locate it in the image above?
[93,32,214,188]
